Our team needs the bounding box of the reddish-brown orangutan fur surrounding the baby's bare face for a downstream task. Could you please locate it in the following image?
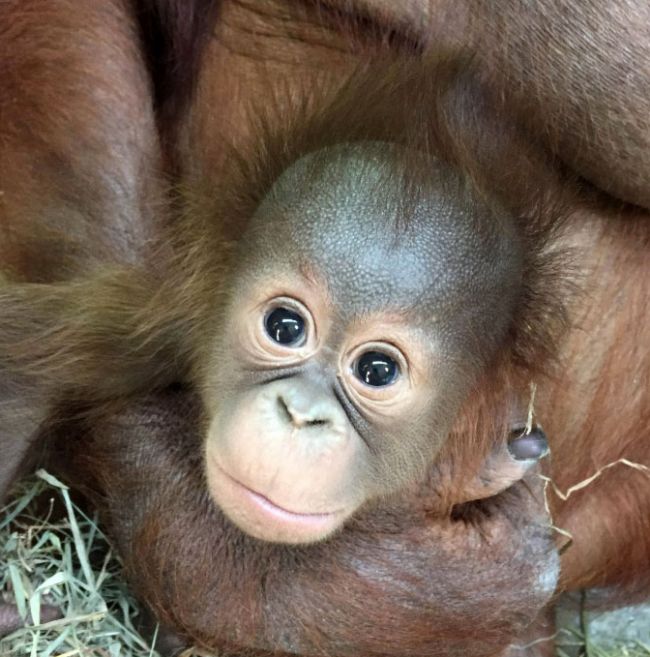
[0,0,650,655]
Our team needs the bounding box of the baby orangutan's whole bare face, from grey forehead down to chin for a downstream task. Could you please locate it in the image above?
[204,144,520,543]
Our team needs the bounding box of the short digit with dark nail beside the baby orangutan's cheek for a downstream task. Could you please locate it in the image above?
[461,426,550,503]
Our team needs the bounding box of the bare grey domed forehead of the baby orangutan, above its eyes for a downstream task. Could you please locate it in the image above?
[239,144,516,326]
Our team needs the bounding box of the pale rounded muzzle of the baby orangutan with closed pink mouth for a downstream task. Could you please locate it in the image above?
[200,387,366,543]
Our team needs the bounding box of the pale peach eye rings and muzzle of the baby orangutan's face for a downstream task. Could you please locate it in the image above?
[207,280,438,542]
